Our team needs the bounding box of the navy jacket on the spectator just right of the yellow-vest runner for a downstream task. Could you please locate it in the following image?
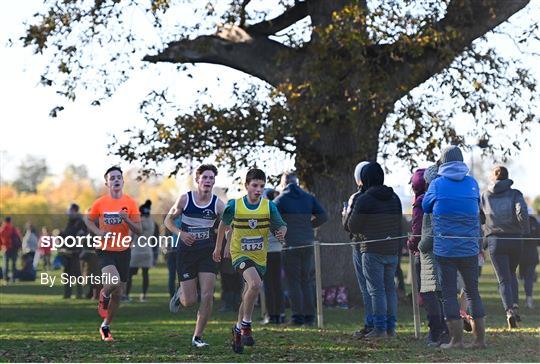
[274,183,328,246]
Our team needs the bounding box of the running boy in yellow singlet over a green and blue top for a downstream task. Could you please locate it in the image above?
[213,168,287,354]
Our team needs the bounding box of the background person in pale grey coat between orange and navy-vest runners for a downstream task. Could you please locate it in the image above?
[127,200,157,302]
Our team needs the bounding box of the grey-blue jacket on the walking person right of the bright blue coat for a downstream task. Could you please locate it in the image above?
[480,179,530,236]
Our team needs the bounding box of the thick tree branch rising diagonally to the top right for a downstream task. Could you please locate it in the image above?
[381,0,530,99]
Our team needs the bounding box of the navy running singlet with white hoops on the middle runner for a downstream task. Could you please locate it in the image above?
[178,191,218,250]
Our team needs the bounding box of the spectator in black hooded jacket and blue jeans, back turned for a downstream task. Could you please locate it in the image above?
[348,162,403,338]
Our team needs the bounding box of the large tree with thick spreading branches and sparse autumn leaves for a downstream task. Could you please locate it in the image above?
[23,0,539,292]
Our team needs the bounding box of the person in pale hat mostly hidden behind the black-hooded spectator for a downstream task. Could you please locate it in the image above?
[342,161,374,337]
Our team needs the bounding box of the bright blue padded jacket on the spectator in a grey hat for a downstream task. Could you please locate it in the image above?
[422,161,480,257]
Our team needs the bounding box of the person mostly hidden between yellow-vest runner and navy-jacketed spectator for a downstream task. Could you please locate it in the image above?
[263,188,285,324]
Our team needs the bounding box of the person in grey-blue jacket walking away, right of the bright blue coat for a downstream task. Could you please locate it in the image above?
[480,166,530,329]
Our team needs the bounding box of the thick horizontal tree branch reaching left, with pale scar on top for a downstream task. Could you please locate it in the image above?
[143,26,304,86]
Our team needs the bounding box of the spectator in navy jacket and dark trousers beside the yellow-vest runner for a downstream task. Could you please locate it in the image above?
[275,172,328,325]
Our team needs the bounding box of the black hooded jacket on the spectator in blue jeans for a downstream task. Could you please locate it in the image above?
[348,163,403,255]
